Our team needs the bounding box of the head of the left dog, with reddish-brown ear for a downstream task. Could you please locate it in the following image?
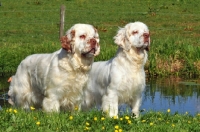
[60,24,100,57]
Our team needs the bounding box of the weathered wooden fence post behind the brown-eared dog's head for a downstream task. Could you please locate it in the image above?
[59,5,65,38]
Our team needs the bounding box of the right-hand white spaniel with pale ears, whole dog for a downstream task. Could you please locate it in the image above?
[82,22,150,117]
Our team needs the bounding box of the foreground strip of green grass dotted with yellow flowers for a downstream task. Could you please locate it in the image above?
[0,108,200,132]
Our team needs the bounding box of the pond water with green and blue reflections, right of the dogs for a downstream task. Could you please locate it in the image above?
[141,78,200,115]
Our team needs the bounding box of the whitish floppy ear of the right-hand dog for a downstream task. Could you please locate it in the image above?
[114,28,131,51]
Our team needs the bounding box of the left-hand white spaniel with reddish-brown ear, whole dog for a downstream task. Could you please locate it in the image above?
[8,24,100,112]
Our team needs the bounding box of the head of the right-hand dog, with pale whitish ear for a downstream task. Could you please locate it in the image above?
[114,22,150,51]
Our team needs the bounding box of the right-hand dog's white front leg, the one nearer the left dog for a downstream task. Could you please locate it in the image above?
[102,90,118,117]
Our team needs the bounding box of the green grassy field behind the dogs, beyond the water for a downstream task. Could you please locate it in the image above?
[0,0,200,77]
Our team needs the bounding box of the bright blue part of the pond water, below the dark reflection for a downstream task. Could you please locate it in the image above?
[141,85,200,115]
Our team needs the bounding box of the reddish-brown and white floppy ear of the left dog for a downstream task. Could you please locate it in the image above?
[60,30,75,53]
